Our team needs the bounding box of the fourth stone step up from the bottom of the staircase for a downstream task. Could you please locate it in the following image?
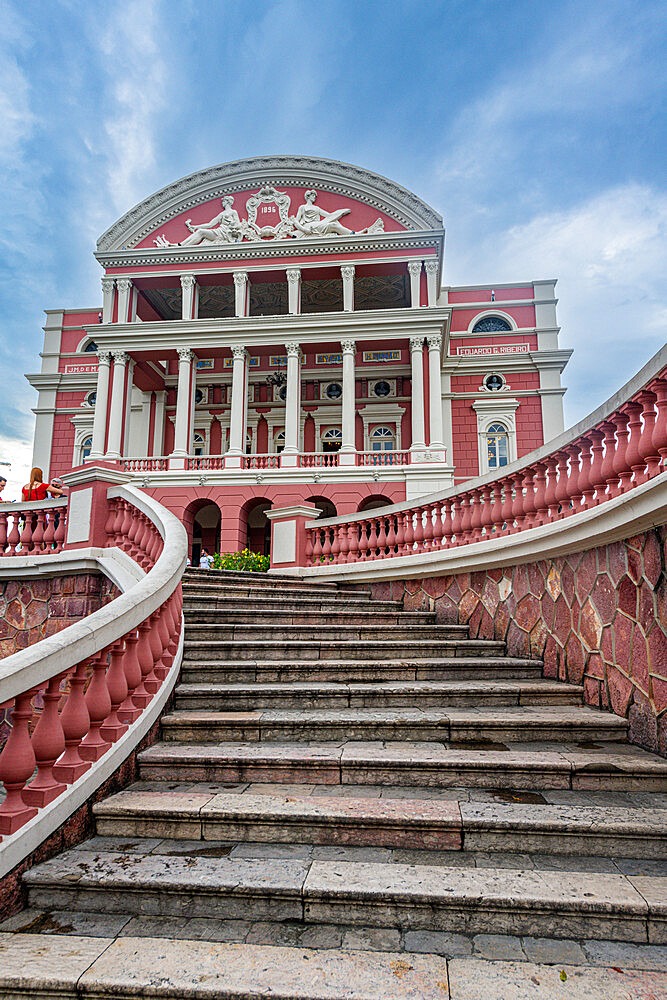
[138,740,667,792]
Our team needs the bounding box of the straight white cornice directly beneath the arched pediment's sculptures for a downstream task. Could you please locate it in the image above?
[95,229,445,273]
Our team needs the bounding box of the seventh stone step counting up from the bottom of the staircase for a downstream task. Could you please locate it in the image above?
[181,656,542,684]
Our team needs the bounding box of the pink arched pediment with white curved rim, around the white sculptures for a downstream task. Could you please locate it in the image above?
[97,156,443,251]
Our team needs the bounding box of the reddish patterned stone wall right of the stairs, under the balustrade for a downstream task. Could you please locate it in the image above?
[372,525,667,755]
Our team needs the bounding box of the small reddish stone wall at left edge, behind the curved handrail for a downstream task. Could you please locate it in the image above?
[0,573,119,659]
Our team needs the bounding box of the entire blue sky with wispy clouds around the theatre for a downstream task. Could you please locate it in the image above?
[0,0,667,495]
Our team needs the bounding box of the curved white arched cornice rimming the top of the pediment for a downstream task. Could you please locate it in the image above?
[97,155,442,251]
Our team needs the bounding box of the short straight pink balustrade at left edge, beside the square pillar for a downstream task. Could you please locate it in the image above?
[0,499,67,556]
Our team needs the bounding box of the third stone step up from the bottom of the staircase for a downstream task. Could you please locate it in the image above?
[93,789,667,860]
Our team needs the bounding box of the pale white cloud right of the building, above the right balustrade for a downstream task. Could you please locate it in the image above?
[448,184,667,423]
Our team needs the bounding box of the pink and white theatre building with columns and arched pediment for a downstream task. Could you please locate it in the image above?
[27,156,570,561]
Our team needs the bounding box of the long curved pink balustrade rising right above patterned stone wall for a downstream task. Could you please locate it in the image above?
[305,349,667,566]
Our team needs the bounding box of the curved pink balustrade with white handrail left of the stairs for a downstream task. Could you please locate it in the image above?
[0,486,187,855]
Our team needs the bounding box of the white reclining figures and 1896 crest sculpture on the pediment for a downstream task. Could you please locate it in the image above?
[153,185,384,247]
